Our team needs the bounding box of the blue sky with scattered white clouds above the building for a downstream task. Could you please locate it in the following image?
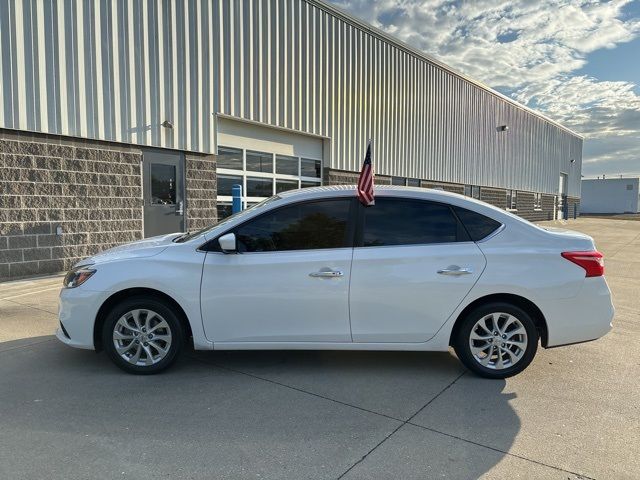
[330,0,640,177]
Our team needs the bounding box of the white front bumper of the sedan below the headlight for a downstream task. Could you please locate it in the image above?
[56,286,108,350]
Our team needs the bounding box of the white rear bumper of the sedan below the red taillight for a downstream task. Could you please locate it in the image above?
[543,277,615,347]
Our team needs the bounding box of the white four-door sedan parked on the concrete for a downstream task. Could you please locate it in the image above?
[57,187,614,378]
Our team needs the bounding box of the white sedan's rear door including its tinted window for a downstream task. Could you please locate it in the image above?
[350,197,485,342]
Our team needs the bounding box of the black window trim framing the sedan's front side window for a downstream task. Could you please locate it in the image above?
[198,196,362,255]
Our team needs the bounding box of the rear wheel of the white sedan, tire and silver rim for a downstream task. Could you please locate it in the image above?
[453,302,539,378]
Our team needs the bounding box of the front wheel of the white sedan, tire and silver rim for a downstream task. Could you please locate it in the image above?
[102,296,184,375]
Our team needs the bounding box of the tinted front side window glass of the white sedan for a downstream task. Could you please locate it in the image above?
[235,199,351,252]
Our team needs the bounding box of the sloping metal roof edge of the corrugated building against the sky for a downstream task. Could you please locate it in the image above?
[303,0,585,140]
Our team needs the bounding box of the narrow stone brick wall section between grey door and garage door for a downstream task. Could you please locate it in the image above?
[185,154,218,231]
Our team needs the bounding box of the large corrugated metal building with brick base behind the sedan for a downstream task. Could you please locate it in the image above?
[0,0,582,278]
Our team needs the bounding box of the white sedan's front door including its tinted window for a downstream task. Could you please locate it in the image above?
[200,198,355,346]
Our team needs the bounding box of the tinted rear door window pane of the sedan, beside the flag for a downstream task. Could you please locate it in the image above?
[364,198,458,247]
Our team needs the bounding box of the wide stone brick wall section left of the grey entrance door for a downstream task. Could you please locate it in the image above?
[0,131,142,281]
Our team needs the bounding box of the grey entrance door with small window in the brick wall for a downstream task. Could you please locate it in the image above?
[143,150,184,237]
